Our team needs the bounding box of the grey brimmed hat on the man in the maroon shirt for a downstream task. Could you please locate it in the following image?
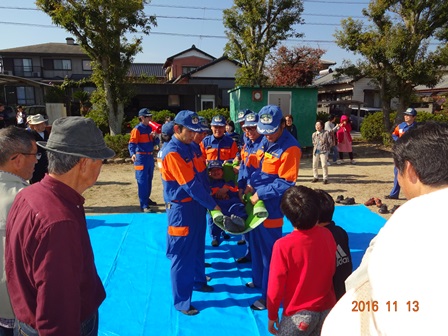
[37,117,115,159]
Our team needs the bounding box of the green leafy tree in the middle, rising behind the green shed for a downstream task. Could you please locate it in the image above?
[224,0,303,86]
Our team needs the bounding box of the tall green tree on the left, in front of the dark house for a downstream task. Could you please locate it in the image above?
[36,0,156,135]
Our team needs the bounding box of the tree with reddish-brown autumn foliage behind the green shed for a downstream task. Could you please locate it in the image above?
[267,46,325,86]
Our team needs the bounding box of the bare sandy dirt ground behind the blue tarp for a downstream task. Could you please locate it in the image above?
[83,142,406,218]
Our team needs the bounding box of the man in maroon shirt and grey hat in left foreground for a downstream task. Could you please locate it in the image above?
[5,117,115,336]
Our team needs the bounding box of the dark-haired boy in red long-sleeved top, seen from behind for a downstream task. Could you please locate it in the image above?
[268,186,336,336]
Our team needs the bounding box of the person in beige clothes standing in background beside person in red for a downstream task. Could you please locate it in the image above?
[311,120,332,184]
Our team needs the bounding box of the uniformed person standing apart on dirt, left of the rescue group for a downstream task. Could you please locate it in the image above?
[128,108,159,212]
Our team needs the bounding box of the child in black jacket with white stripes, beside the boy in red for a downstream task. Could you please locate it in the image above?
[316,189,353,300]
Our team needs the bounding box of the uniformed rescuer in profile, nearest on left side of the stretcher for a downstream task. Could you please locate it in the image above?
[162,110,222,315]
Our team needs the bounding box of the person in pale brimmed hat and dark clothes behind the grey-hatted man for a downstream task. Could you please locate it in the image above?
[27,114,49,184]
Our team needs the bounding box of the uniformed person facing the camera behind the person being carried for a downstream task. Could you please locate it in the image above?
[201,115,238,247]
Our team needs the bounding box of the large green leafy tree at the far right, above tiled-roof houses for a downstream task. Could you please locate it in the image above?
[334,0,448,131]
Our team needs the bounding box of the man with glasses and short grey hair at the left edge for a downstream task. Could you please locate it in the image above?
[0,126,39,336]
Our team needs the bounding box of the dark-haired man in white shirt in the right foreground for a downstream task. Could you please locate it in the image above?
[322,122,448,336]
